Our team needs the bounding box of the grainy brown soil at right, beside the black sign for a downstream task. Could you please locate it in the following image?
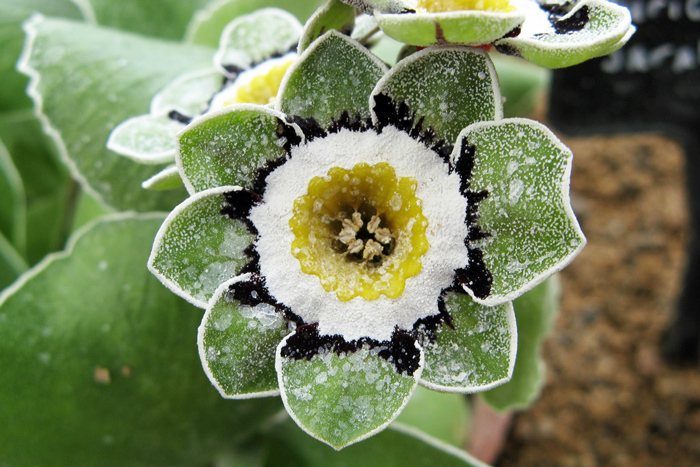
[497,135,700,467]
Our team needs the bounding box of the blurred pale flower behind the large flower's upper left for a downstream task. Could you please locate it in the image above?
[107,8,302,188]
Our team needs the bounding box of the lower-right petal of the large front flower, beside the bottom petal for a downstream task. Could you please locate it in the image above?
[420,292,518,393]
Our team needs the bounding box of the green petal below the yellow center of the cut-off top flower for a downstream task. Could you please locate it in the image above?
[374,10,525,47]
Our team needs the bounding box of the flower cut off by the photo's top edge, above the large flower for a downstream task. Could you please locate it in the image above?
[343,0,635,68]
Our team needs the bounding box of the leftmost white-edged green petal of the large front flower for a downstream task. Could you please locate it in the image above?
[148,186,255,308]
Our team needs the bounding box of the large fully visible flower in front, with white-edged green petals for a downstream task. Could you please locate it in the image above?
[149,30,585,449]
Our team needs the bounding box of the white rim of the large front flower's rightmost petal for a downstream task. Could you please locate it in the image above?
[450,117,587,306]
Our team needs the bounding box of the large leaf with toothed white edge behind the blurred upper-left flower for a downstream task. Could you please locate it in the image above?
[19,17,212,211]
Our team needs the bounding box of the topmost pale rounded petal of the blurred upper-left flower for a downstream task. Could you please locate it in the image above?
[214,8,302,74]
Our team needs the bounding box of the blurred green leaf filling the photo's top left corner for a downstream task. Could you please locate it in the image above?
[0,0,82,111]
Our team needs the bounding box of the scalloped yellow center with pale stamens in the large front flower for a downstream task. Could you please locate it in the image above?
[289,163,429,301]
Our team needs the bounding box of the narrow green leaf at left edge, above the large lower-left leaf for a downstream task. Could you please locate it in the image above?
[0,139,27,251]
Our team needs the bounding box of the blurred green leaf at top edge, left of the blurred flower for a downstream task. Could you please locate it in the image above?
[76,0,207,40]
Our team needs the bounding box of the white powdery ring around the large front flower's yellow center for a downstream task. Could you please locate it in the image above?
[250,127,469,341]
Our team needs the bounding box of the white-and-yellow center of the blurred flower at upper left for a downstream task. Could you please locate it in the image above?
[212,54,296,108]
